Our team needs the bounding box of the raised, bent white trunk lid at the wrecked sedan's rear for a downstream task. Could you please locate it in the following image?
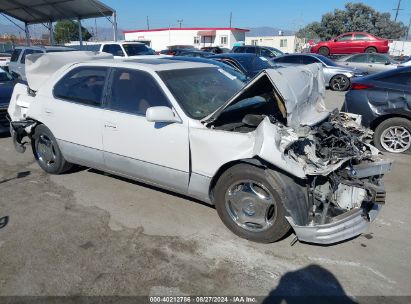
[25,51,113,91]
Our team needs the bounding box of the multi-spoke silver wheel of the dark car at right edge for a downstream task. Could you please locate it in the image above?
[374,117,411,153]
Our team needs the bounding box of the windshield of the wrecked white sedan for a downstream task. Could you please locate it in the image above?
[158,67,244,119]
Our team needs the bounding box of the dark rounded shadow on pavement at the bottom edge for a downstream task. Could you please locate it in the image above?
[262,264,356,304]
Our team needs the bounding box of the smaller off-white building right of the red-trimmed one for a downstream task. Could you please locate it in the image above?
[245,35,304,53]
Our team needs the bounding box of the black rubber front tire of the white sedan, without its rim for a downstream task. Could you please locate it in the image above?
[214,164,290,243]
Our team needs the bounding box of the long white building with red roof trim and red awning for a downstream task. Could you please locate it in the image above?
[124,27,249,51]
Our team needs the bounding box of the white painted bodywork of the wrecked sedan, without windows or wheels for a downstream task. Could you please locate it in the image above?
[8,52,391,243]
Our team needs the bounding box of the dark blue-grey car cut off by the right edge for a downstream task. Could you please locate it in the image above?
[342,67,411,153]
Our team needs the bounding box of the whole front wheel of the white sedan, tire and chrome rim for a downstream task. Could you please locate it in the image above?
[215,164,290,243]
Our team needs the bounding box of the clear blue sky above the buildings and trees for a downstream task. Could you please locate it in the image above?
[99,0,411,30]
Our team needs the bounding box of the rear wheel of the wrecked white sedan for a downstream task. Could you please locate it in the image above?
[32,125,73,174]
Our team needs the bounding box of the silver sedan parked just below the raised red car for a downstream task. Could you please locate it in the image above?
[336,53,398,74]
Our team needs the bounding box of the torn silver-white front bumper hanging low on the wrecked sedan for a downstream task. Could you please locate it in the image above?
[287,204,381,244]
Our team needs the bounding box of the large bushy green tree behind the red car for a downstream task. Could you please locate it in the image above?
[296,2,407,40]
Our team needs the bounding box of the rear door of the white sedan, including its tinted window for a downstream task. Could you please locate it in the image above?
[42,66,108,169]
